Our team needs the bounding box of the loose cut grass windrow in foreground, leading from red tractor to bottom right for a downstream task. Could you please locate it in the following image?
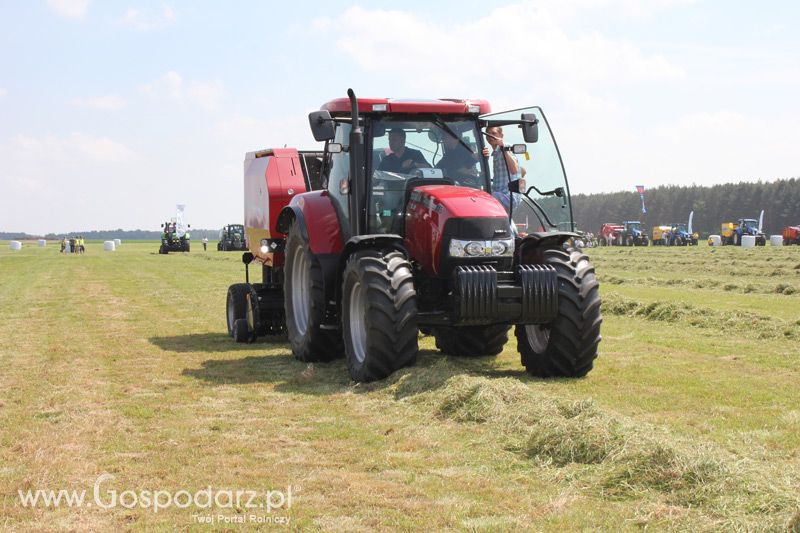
[376,361,800,530]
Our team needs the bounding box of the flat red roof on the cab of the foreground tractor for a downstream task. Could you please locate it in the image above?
[320,98,492,115]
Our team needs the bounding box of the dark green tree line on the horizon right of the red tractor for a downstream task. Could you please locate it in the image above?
[572,178,800,238]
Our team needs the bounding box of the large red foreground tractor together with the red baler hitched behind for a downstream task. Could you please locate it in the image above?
[227,90,602,381]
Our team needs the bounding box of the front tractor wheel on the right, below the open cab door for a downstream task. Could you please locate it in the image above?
[515,249,603,377]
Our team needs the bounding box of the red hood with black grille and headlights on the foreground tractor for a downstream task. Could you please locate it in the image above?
[405,185,513,276]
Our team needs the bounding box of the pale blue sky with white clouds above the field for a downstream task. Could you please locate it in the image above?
[0,0,800,233]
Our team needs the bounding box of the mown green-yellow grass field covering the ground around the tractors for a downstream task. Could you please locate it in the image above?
[0,242,800,532]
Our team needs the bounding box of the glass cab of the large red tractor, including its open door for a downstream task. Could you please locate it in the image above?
[309,99,574,251]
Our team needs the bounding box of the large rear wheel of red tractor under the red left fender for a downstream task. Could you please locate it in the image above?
[283,222,342,362]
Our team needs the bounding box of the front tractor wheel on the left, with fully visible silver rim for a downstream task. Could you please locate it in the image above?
[342,250,419,382]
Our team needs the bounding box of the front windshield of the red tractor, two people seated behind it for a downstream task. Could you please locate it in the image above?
[367,115,489,233]
